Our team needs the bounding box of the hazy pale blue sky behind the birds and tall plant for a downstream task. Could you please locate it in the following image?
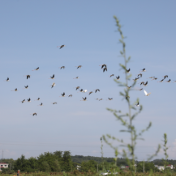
[0,0,176,160]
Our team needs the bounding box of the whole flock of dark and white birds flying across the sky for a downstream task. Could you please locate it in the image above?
[6,45,176,116]
